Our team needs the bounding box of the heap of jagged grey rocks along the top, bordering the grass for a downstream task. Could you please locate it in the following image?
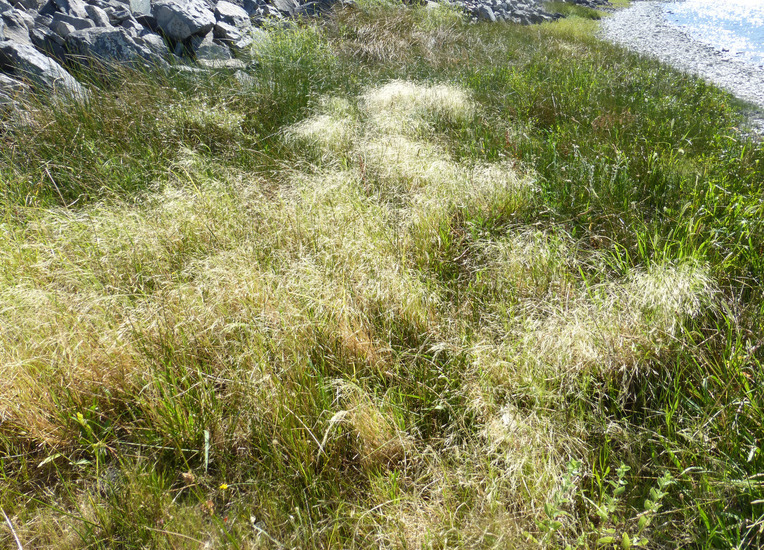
[0,0,607,105]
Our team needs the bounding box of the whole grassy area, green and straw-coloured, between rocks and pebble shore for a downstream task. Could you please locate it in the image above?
[0,2,764,549]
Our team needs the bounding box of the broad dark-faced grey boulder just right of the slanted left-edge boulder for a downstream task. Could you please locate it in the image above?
[66,27,164,64]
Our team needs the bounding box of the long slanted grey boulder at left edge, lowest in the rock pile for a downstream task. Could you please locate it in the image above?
[0,41,86,98]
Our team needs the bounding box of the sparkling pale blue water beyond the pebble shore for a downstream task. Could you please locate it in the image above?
[663,0,764,65]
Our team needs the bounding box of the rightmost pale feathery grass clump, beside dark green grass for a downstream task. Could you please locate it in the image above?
[520,265,715,378]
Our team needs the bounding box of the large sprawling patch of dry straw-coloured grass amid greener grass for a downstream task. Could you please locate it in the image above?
[0,75,715,548]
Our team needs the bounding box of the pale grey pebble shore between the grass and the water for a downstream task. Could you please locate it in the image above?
[602,2,764,133]
